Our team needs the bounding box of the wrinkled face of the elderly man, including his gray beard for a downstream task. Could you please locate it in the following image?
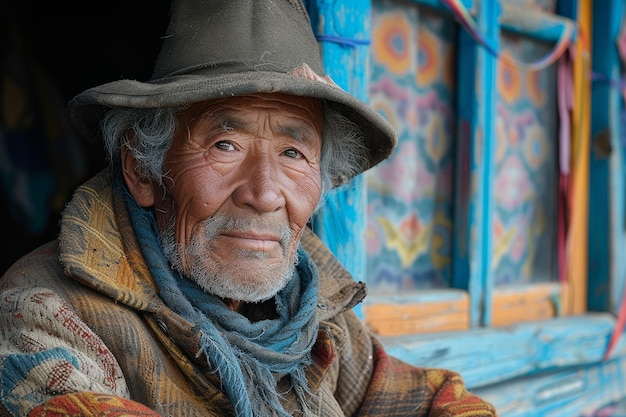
[154,94,322,302]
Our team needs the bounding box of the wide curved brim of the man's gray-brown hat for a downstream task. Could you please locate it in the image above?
[69,71,397,172]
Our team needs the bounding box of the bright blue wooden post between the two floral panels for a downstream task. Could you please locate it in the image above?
[454,2,499,328]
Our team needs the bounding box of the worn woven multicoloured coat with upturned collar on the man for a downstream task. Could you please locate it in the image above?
[0,171,496,417]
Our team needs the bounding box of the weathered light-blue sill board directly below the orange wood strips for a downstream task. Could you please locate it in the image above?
[381,313,626,389]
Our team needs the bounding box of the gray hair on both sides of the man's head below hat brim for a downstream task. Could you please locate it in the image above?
[100,101,368,209]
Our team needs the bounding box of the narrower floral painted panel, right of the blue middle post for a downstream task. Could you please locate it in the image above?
[492,33,559,285]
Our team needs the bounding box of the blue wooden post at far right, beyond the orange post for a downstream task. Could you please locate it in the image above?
[588,0,625,312]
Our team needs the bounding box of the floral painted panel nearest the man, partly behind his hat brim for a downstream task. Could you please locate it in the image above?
[366,1,456,290]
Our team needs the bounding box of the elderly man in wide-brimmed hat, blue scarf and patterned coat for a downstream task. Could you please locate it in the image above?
[0,0,495,417]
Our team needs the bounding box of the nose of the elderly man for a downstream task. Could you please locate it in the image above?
[233,158,286,213]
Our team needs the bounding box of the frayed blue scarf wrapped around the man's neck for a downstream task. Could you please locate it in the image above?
[118,181,318,417]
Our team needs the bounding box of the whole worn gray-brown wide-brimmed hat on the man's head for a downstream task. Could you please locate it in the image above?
[69,0,397,177]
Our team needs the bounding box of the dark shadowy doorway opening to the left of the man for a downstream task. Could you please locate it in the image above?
[0,0,169,274]
